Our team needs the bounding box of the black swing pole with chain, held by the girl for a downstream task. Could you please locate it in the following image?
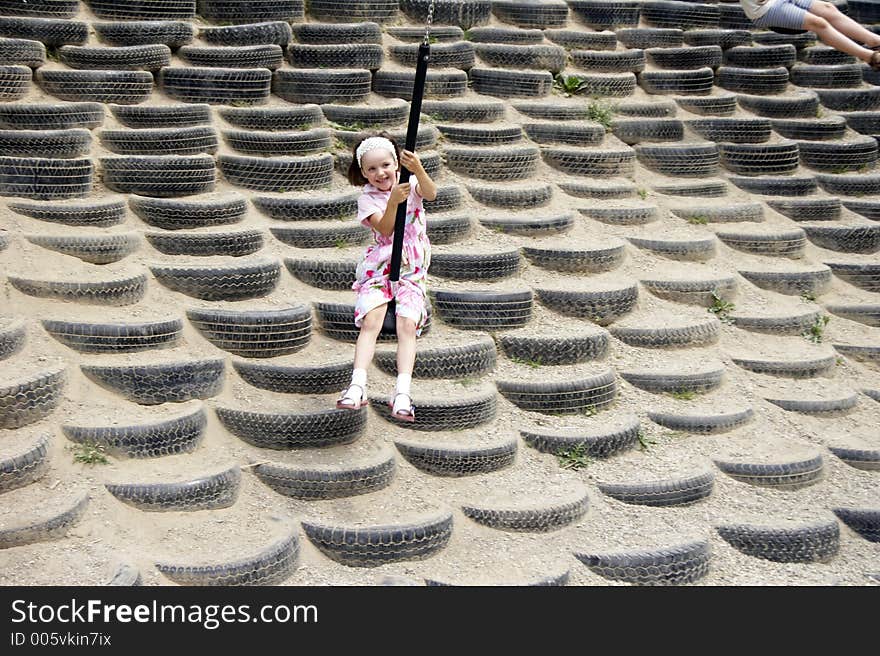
[382,0,434,335]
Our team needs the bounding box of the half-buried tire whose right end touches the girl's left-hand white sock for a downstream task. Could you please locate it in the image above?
[232,361,352,394]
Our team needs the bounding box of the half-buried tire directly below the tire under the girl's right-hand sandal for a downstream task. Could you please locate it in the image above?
[394,439,517,477]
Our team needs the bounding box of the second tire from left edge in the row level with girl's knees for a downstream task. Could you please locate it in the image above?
[42,319,183,353]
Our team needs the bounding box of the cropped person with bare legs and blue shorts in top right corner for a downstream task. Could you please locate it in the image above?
[740,0,880,70]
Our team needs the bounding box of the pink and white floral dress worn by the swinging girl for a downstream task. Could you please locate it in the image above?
[351,175,431,335]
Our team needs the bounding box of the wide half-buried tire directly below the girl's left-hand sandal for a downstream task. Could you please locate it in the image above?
[216,407,367,450]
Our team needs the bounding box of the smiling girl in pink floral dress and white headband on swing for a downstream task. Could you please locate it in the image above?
[336,133,437,421]
